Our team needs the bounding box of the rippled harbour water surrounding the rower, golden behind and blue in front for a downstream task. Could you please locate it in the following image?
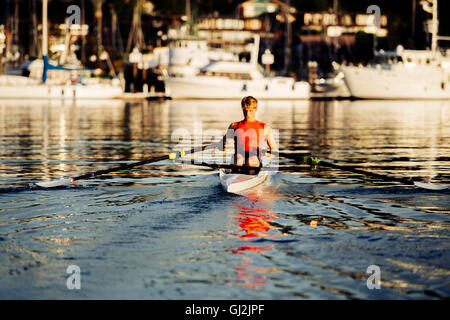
[0,100,450,299]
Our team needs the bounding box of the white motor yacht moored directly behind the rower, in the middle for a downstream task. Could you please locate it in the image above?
[164,37,310,100]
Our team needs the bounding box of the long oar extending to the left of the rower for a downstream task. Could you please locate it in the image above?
[36,144,215,188]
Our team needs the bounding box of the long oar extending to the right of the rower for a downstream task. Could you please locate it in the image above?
[271,152,449,190]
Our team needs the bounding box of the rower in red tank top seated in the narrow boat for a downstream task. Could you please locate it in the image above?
[216,96,278,172]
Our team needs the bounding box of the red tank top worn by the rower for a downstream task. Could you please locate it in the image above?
[233,120,266,154]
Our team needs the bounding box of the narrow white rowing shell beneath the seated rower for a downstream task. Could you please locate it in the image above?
[219,169,269,193]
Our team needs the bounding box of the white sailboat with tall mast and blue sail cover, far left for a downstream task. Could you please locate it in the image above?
[0,0,123,100]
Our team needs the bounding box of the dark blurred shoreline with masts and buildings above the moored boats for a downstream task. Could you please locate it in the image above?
[0,0,450,92]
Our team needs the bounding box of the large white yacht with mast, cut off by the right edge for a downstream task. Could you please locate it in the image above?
[340,0,450,99]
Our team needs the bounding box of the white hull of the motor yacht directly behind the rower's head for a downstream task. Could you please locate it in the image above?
[165,76,310,100]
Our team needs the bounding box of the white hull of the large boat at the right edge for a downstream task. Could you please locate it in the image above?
[341,66,450,99]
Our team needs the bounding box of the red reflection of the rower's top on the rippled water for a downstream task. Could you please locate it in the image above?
[229,190,282,289]
